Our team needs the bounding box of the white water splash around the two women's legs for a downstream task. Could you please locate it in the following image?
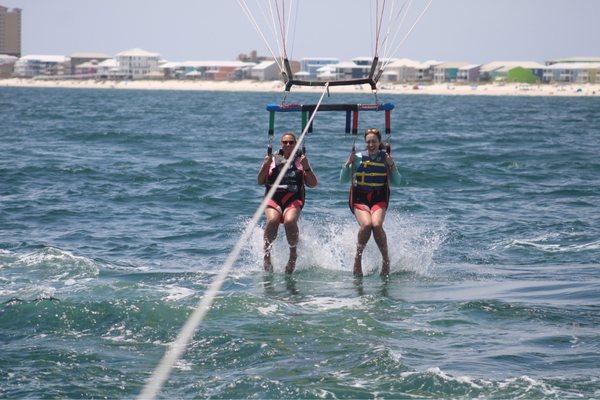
[242,211,444,275]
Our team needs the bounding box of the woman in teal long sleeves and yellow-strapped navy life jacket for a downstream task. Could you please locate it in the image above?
[340,128,400,276]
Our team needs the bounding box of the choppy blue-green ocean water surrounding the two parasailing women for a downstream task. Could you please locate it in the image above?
[0,88,600,399]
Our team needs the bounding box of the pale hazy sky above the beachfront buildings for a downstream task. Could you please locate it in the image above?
[0,0,600,63]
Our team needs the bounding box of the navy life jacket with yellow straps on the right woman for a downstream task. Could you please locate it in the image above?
[348,150,390,213]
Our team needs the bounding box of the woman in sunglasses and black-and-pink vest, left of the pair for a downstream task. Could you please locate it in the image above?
[257,132,317,274]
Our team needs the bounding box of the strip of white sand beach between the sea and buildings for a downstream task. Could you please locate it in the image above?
[0,78,600,97]
